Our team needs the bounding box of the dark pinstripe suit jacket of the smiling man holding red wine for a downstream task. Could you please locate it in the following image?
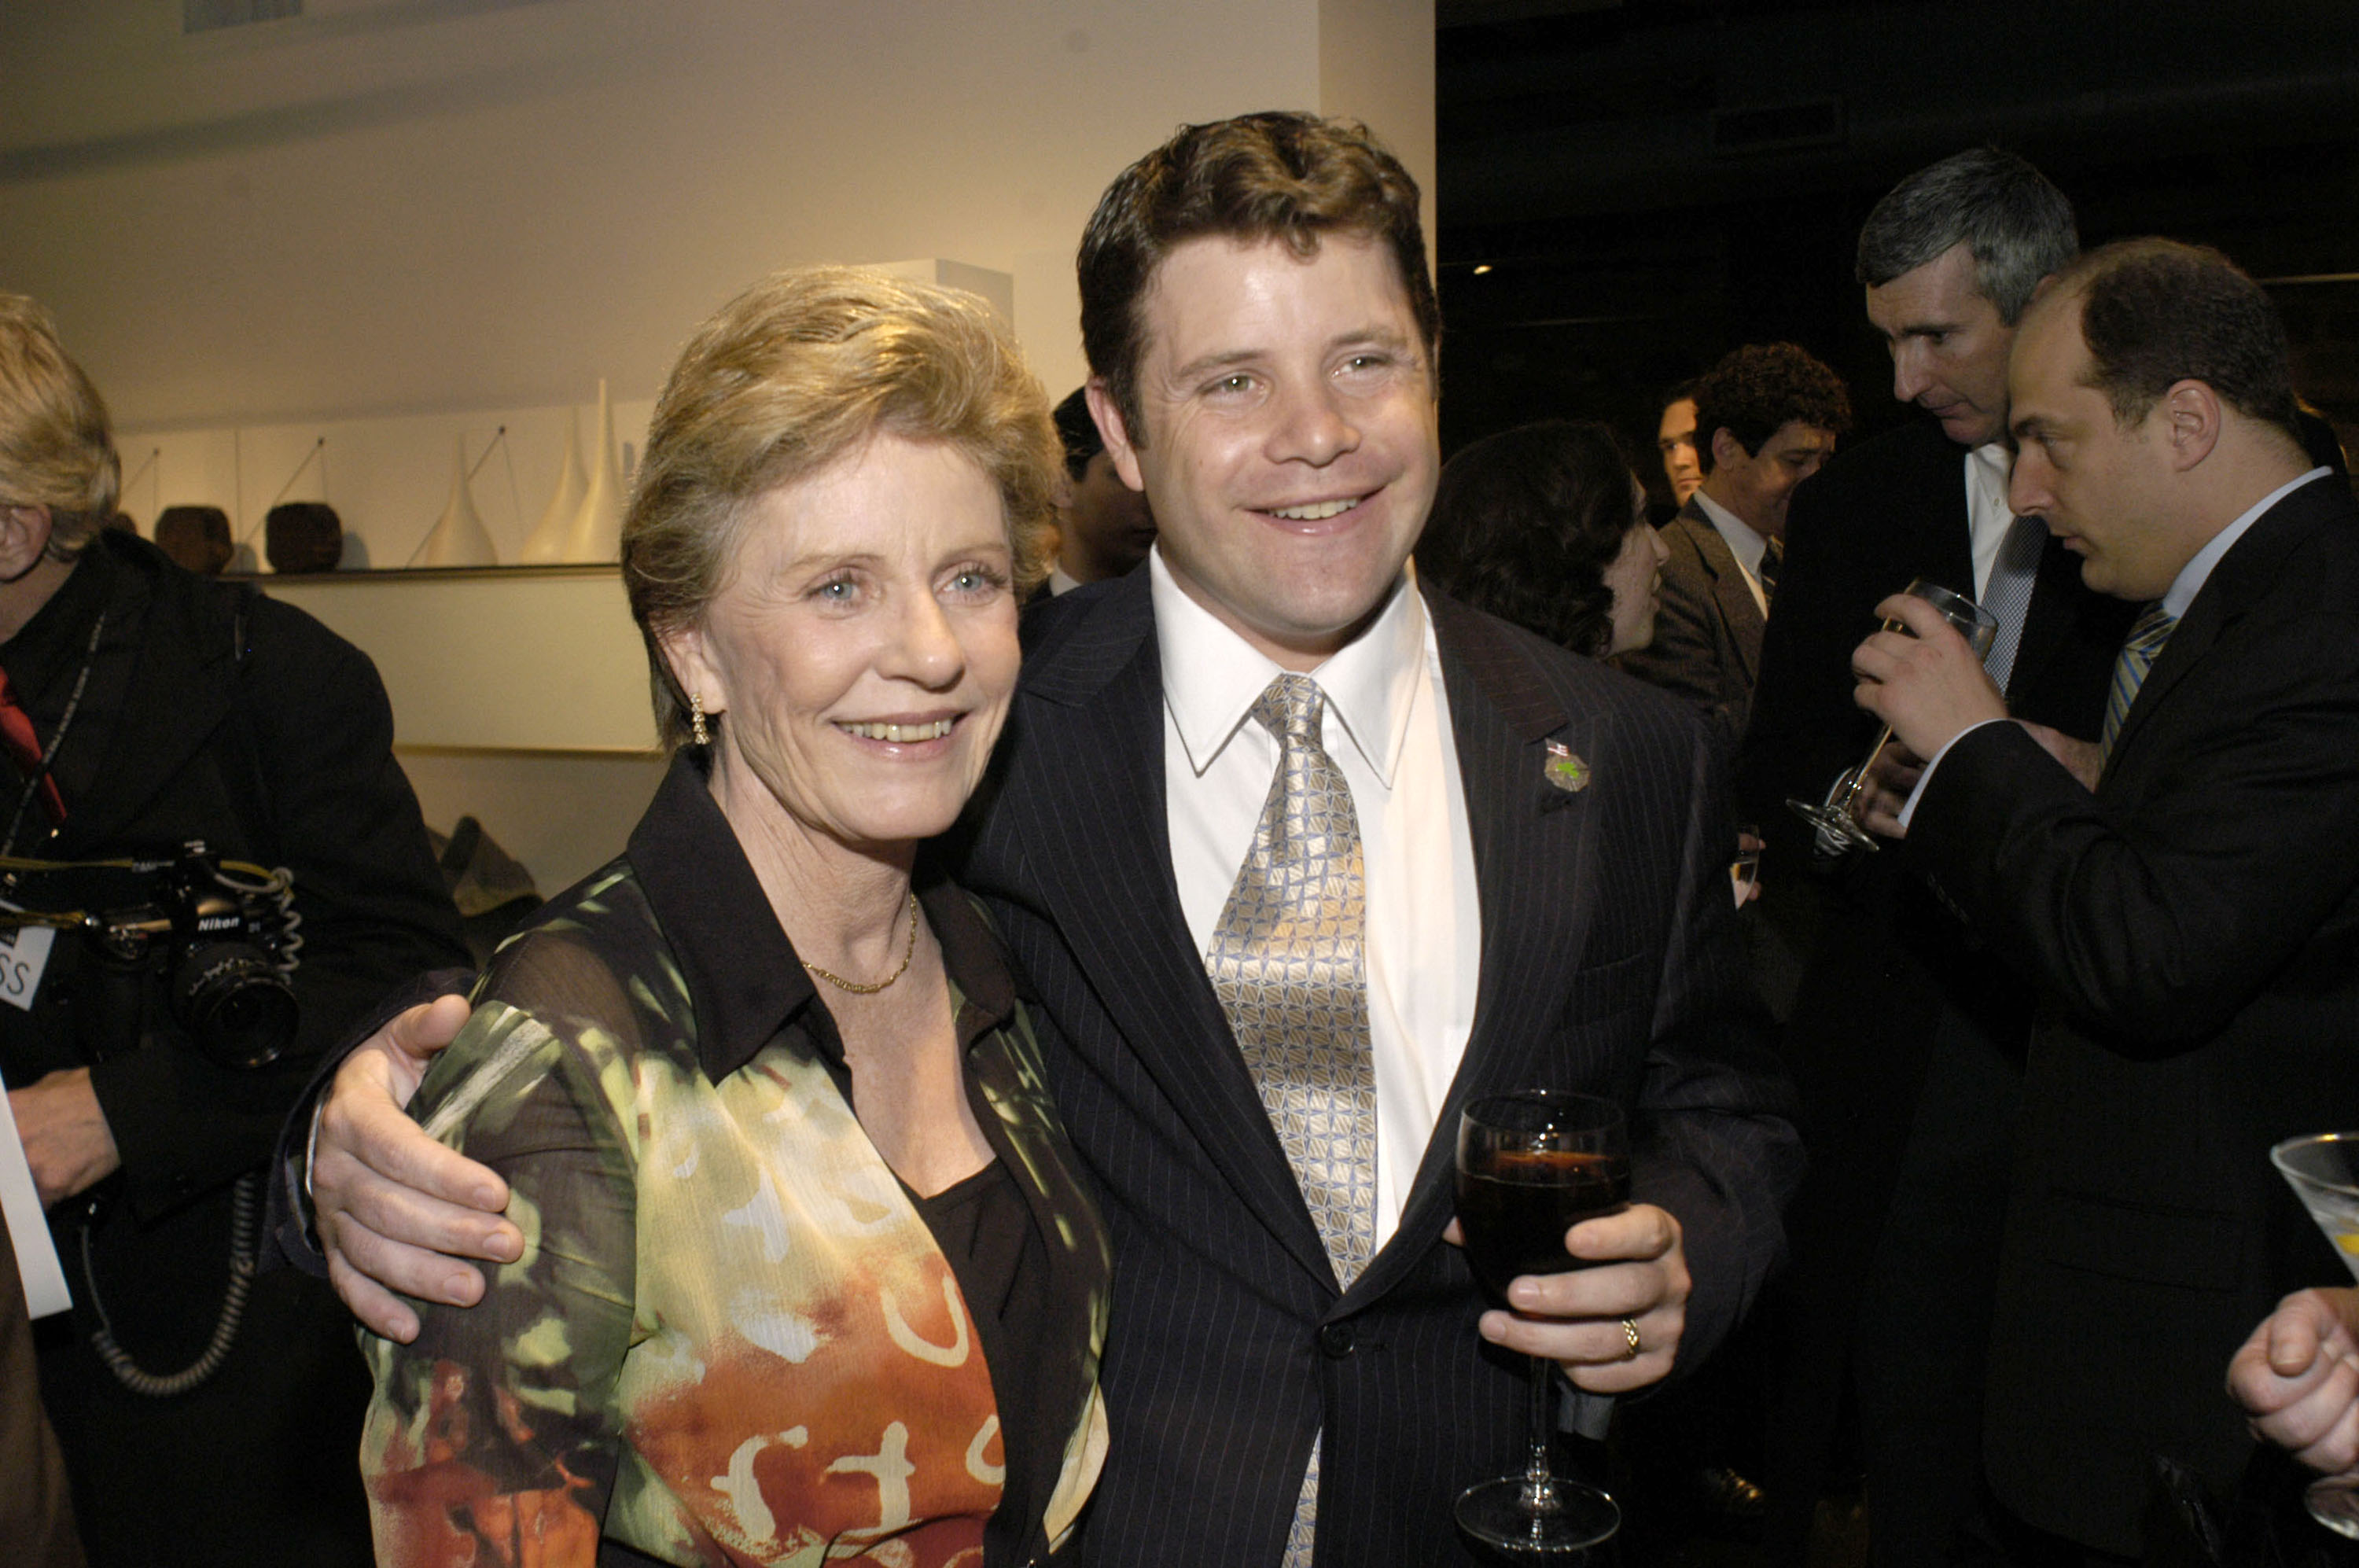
[962,571,1798,1568]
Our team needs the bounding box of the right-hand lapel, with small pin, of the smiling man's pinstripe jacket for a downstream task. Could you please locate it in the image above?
[1342,592,1611,1311]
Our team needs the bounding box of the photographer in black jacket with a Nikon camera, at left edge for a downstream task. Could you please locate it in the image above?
[0,295,467,1566]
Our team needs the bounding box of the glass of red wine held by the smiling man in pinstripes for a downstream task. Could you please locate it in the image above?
[1458,1089,1630,1556]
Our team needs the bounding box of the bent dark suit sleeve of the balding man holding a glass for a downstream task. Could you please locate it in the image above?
[1908,606,2359,1056]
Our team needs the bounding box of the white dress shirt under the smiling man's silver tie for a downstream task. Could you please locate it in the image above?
[1149,547,1481,1247]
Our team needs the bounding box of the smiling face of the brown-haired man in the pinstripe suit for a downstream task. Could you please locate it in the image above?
[1090,234,1441,670]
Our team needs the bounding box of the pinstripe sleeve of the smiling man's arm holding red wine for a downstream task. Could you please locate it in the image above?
[1630,707,1802,1367]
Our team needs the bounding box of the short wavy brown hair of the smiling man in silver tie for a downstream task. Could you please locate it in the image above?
[1078,111,1441,446]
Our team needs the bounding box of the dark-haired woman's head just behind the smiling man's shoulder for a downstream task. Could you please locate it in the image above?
[1418,420,1668,658]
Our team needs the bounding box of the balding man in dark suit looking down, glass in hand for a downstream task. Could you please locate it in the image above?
[1854,241,2359,1561]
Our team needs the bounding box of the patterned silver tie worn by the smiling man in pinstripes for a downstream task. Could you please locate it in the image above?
[1203,672,1375,1568]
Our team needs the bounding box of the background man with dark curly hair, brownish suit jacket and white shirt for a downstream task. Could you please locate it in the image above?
[1616,342,1852,750]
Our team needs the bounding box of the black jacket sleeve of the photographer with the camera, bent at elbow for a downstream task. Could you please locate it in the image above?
[92,602,467,1212]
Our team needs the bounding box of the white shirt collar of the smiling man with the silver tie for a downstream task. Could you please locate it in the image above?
[1146,545,1425,787]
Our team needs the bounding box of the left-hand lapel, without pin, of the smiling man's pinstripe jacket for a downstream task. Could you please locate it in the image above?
[1005,571,1335,1285]
